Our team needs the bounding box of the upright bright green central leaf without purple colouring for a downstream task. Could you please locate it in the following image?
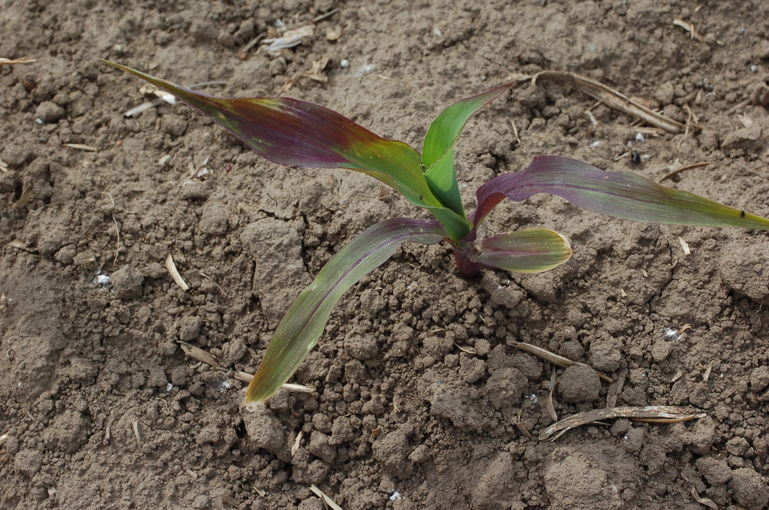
[422,83,512,216]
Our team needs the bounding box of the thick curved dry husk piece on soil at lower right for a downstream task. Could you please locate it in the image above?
[539,406,706,441]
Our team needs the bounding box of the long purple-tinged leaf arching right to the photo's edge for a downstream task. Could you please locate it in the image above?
[468,156,769,233]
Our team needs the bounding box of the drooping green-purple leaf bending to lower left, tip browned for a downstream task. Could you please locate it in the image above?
[246,218,446,402]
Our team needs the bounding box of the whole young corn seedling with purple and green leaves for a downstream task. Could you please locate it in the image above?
[105,61,769,402]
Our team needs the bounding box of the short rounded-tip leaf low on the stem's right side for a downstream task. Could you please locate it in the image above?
[470,228,571,273]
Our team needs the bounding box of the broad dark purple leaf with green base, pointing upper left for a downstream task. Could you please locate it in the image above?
[103,60,470,239]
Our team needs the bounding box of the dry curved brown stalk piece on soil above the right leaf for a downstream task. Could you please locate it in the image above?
[531,71,697,134]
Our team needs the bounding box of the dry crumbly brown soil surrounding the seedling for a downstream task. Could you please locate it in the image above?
[0,0,769,510]
